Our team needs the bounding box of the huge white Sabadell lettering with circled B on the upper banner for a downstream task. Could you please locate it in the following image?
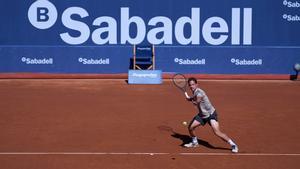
[28,0,252,45]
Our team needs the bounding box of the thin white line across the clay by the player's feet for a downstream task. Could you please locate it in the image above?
[0,152,300,156]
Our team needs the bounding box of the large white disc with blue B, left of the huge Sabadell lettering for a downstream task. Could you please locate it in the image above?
[28,0,57,29]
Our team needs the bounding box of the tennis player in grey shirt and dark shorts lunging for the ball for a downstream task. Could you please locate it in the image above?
[184,78,238,153]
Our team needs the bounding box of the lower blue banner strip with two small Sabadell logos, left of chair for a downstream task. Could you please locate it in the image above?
[0,46,132,73]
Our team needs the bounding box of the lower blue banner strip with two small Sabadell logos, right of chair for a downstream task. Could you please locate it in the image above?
[156,46,300,74]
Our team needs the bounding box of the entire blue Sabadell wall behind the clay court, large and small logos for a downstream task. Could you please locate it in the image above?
[0,0,300,74]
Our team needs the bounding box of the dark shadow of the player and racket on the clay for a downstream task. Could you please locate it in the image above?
[158,126,231,150]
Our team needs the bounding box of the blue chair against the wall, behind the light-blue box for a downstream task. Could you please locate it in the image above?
[133,44,155,70]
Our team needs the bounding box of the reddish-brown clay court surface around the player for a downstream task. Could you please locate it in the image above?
[0,79,300,169]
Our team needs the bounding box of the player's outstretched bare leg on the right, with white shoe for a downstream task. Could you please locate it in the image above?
[210,119,238,153]
